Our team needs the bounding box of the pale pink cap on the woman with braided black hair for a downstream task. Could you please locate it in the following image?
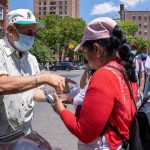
[74,17,117,51]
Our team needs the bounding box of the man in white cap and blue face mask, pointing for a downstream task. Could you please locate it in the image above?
[0,9,69,138]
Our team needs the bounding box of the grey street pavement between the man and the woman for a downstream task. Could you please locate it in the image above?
[32,70,83,150]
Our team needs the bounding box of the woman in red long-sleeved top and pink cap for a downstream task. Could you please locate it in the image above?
[52,17,137,150]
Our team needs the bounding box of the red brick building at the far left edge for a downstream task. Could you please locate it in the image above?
[0,0,9,38]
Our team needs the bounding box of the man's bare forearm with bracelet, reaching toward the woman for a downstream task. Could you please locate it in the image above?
[0,75,45,95]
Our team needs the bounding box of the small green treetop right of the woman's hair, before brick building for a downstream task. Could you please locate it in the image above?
[118,20,138,37]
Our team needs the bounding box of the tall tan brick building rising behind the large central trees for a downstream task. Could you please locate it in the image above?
[34,0,79,19]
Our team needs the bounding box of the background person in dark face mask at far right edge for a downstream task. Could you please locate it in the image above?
[137,45,150,97]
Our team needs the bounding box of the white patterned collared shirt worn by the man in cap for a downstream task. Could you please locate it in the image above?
[0,37,40,136]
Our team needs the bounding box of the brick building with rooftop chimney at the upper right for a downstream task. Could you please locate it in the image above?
[120,4,150,39]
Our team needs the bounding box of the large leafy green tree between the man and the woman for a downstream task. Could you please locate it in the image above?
[31,15,86,61]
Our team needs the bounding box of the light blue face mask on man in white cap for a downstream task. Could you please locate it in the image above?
[14,34,35,52]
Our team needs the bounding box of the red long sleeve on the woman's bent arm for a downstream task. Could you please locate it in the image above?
[60,68,119,143]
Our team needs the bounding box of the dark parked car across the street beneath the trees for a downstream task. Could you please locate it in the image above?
[49,61,74,71]
